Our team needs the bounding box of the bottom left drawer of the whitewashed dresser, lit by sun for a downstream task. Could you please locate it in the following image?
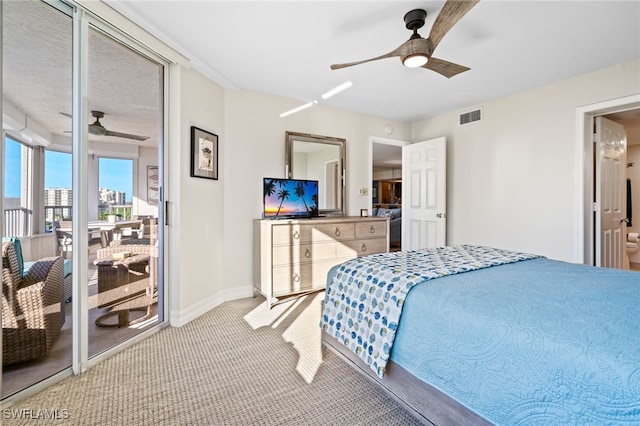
[272,261,336,296]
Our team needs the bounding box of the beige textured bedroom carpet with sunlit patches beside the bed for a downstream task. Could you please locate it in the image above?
[0,293,419,426]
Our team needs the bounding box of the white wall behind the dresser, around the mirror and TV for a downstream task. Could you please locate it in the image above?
[222,90,410,296]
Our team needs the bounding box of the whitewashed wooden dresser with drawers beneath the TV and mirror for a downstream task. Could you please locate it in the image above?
[253,216,389,307]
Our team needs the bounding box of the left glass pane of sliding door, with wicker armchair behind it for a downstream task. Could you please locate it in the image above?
[2,1,72,399]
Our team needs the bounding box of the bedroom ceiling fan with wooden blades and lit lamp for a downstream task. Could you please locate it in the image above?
[331,0,480,78]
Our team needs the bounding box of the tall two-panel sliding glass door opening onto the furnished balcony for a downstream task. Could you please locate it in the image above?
[0,0,167,400]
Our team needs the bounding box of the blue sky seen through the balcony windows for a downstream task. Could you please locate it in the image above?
[4,138,133,201]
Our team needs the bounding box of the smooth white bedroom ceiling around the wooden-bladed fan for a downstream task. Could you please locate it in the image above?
[104,0,640,122]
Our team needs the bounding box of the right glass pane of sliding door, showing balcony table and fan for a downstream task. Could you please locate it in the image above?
[87,27,163,357]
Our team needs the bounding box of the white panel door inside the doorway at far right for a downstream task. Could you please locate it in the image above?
[594,117,627,268]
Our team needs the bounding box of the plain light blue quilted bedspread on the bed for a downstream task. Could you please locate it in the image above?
[391,259,640,425]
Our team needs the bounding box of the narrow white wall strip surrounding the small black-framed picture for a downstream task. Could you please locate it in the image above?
[167,65,230,326]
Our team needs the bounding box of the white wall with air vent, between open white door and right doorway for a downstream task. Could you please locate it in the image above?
[411,60,640,261]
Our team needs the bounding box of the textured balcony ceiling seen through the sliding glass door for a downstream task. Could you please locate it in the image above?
[3,1,162,147]
